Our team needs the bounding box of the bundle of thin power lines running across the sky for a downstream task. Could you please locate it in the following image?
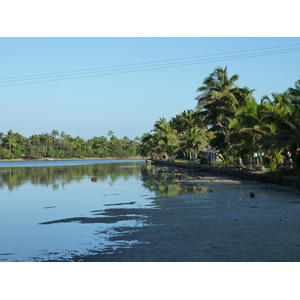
[0,44,300,87]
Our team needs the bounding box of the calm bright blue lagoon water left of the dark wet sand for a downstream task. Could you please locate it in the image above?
[0,160,157,261]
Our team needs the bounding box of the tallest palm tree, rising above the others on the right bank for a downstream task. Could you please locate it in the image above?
[196,67,260,164]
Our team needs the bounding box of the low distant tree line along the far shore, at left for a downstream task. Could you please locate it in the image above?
[0,130,140,159]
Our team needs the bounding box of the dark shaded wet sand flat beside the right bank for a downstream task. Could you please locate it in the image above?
[74,174,300,262]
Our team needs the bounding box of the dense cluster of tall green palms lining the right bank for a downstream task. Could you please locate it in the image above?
[141,67,300,171]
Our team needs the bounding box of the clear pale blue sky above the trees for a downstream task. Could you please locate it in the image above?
[0,37,300,139]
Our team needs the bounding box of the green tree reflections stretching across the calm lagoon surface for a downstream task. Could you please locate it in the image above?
[0,161,209,197]
